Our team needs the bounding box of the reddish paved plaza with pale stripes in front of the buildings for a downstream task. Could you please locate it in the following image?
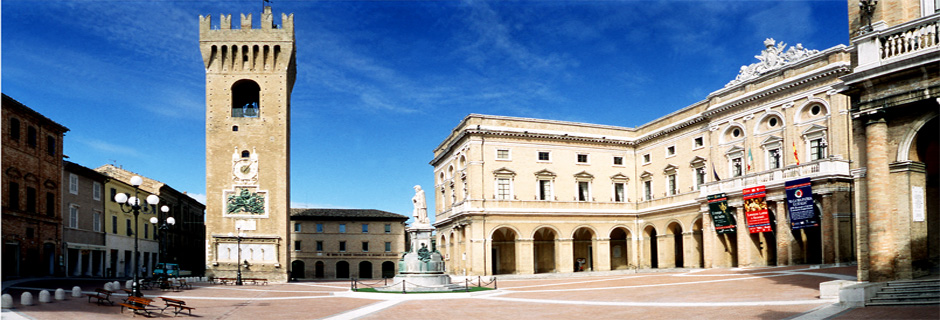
[3,266,940,320]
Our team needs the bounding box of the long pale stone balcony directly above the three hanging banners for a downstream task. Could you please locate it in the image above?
[699,158,852,197]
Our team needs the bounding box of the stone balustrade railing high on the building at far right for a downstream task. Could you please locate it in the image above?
[855,14,940,72]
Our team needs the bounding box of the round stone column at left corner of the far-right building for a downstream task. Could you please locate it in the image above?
[859,117,898,282]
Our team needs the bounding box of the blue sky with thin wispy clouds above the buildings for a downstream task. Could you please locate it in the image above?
[0,0,848,222]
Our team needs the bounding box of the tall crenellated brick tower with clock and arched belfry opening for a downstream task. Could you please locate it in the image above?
[199,7,297,282]
